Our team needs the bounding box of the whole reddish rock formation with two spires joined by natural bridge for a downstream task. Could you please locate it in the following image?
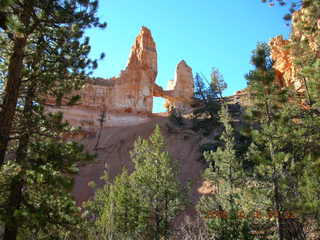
[48,27,193,128]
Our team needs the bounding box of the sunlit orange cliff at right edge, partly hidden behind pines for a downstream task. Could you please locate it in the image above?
[269,8,320,92]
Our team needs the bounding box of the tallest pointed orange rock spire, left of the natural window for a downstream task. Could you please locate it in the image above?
[106,27,157,113]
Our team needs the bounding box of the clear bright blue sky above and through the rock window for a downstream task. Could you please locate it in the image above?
[87,0,290,112]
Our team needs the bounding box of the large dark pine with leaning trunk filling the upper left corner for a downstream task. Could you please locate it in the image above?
[0,0,104,166]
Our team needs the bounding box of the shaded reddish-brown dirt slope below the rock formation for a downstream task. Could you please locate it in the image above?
[73,115,203,222]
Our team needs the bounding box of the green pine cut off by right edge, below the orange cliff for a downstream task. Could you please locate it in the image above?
[283,109,320,235]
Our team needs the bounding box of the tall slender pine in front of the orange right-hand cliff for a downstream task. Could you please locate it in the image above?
[246,44,292,240]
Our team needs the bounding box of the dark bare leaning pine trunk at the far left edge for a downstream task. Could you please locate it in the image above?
[0,37,27,167]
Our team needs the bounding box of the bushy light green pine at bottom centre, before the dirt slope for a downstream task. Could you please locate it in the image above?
[85,126,184,240]
